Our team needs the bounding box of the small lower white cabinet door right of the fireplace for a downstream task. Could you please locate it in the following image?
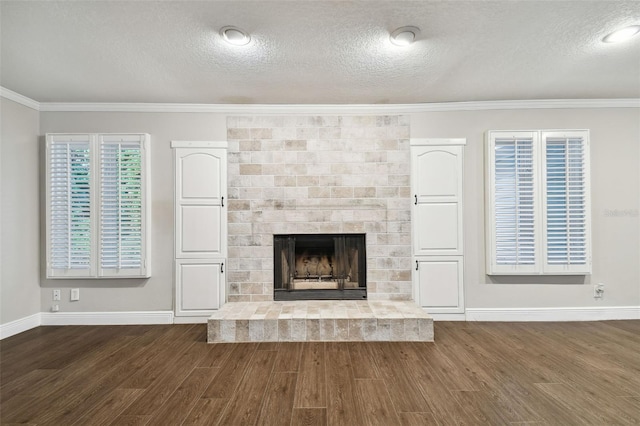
[414,256,464,314]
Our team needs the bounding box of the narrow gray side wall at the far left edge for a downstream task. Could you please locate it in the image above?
[0,98,40,324]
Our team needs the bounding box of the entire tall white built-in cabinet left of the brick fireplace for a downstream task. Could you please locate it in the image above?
[171,141,227,317]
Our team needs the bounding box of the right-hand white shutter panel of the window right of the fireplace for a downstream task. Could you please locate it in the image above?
[542,132,591,273]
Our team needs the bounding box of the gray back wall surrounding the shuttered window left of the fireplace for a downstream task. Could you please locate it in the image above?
[40,112,227,312]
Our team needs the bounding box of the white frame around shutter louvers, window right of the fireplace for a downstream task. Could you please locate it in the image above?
[484,129,592,275]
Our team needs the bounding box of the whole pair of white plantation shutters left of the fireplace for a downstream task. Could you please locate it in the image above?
[46,134,151,278]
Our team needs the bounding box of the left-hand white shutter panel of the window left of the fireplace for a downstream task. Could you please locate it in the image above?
[46,135,95,277]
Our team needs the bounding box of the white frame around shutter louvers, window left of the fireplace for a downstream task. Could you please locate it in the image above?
[45,133,151,279]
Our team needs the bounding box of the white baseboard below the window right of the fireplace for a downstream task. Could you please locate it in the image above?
[466,306,640,322]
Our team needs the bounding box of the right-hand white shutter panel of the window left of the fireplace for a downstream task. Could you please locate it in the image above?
[99,135,146,276]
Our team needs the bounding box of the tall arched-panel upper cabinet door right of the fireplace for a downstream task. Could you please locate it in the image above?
[412,146,463,256]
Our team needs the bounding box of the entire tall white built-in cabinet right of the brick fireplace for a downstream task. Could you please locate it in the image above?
[411,139,466,314]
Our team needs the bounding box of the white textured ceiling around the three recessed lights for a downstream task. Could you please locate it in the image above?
[0,0,640,104]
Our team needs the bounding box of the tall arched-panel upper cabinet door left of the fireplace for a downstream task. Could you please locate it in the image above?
[175,148,227,259]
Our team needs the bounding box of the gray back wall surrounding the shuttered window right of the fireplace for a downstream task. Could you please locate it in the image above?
[411,108,640,308]
